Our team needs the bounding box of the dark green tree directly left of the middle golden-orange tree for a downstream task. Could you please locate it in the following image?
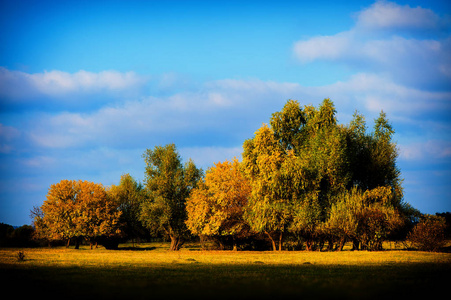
[140,144,202,250]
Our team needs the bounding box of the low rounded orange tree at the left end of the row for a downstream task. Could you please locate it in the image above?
[34,180,121,249]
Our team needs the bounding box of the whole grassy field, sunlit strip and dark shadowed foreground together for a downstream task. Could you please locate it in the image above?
[0,243,451,299]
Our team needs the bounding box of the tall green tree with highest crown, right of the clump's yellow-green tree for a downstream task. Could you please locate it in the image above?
[271,99,349,250]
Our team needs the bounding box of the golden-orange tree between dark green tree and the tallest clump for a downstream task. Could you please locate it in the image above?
[186,158,250,249]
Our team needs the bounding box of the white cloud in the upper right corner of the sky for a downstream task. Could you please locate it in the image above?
[293,2,451,90]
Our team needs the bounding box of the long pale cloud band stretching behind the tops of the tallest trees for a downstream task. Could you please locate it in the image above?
[23,73,451,154]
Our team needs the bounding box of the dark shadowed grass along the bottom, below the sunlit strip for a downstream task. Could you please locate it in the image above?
[0,263,451,299]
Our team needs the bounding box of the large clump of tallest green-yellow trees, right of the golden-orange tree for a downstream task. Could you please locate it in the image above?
[243,99,408,250]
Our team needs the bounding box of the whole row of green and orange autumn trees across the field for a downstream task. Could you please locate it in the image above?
[33,99,444,250]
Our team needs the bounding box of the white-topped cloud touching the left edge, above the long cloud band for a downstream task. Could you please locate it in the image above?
[0,67,147,110]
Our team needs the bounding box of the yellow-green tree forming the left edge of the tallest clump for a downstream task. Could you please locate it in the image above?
[243,125,292,251]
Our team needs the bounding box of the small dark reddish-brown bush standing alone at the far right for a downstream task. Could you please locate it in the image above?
[407,215,446,251]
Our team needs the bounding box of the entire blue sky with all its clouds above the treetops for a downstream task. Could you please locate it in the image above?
[0,0,451,225]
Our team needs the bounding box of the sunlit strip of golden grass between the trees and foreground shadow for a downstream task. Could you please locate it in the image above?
[0,243,451,268]
